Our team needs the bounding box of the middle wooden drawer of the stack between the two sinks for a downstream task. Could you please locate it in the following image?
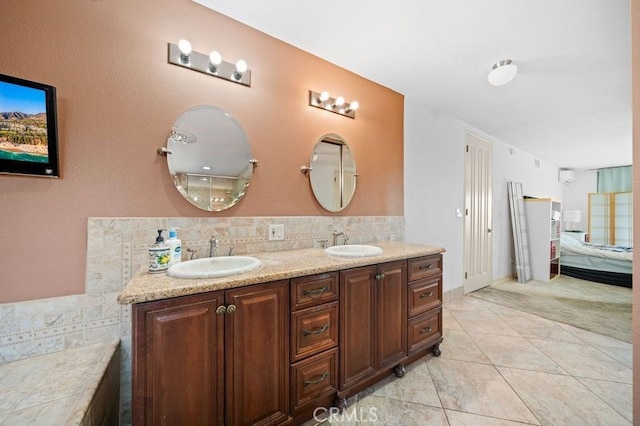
[291,302,338,362]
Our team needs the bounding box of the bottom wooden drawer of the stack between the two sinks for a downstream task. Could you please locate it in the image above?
[291,349,338,411]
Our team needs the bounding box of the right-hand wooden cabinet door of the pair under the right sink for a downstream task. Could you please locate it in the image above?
[375,261,407,369]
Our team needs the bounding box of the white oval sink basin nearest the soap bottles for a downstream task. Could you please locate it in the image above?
[167,256,260,278]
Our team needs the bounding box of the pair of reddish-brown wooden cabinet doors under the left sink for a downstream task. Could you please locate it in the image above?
[132,281,289,425]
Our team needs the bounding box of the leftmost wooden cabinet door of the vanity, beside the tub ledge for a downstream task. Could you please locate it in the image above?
[133,291,224,425]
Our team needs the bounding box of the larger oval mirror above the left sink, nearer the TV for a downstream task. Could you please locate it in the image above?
[165,105,256,211]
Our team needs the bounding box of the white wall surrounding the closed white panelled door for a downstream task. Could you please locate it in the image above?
[404,97,564,291]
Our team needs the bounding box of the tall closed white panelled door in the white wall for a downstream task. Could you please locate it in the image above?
[464,133,493,294]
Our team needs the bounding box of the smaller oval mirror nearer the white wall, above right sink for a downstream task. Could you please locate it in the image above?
[309,133,358,212]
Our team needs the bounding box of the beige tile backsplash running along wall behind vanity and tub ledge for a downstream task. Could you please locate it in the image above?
[0,216,404,424]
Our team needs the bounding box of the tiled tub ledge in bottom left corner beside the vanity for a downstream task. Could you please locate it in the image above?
[0,339,120,426]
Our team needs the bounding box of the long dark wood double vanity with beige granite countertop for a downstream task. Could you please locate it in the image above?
[118,242,444,425]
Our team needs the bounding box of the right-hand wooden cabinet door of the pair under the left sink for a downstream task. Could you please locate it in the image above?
[225,281,289,425]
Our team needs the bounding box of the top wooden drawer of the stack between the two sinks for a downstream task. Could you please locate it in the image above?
[291,272,338,311]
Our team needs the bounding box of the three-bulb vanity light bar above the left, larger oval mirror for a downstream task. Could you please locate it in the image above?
[169,39,251,87]
